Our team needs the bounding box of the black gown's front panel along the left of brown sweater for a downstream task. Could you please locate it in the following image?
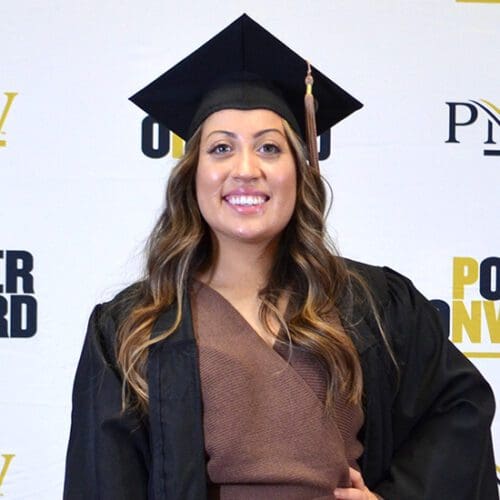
[148,293,207,500]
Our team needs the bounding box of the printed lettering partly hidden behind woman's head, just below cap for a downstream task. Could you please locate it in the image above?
[141,116,331,161]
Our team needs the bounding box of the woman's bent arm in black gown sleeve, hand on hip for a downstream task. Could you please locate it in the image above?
[372,270,498,500]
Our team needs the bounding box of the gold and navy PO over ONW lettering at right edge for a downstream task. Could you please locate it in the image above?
[431,257,500,358]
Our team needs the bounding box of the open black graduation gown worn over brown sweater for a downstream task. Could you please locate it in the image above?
[64,261,498,500]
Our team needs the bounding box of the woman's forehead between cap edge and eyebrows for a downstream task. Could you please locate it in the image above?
[202,109,285,140]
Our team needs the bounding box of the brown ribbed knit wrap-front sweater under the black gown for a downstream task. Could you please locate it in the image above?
[191,283,363,500]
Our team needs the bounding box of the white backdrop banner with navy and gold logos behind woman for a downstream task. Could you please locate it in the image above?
[0,0,500,500]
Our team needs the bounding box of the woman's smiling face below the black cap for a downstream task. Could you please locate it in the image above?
[196,109,297,249]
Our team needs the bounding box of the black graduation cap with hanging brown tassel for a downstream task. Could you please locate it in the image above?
[130,14,362,167]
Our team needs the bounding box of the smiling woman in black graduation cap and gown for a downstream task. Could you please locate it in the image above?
[65,16,498,500]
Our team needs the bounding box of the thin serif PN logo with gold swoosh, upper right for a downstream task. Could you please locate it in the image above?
[445,99,500,156]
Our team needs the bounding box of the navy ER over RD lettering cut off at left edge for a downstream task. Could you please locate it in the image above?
[0,250,37,338]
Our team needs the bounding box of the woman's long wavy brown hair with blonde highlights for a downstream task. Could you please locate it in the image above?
[117,121,386,412]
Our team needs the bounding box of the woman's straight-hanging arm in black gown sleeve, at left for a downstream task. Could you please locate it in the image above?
[64,306,150,500]
